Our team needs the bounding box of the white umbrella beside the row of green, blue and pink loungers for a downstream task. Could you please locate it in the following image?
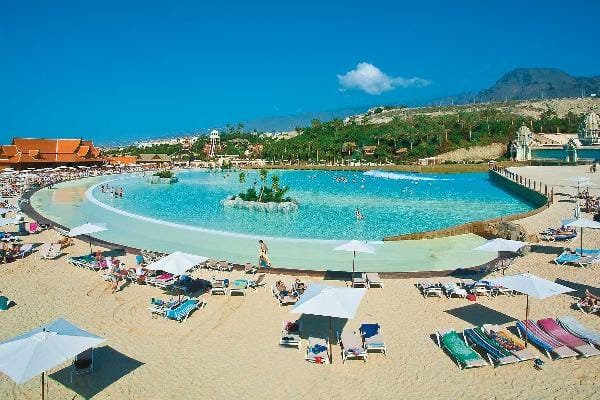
[489,273,575,345]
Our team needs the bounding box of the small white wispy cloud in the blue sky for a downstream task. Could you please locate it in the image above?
[337,62,431,95]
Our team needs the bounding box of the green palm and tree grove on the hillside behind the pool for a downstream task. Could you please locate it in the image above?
[106,107,583,164]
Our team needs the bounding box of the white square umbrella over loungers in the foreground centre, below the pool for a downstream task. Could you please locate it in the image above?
[290,284,367,361]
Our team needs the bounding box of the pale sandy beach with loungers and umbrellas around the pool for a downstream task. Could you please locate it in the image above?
[0,167,600,400]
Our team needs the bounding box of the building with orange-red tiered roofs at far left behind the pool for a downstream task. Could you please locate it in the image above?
[0,138,104,169]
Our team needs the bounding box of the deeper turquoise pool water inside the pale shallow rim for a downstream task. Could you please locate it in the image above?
[93,170,532,240]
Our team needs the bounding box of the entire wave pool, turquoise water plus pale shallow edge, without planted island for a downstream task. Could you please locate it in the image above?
[30,170,533,272]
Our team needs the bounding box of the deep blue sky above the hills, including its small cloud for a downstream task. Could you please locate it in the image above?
[0,0,600,142]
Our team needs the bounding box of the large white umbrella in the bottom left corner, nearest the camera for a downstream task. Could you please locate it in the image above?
[0,318,105,399]
